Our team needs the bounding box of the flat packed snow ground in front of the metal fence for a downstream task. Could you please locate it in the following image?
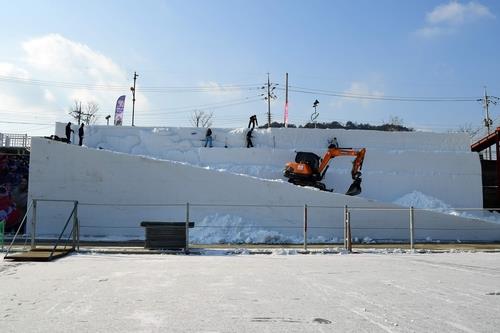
[0,253,500,333]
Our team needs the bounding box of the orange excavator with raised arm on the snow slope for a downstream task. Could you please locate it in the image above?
[283,146,366,195]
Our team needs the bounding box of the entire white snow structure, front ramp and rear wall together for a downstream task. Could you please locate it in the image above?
[29,124,500,243]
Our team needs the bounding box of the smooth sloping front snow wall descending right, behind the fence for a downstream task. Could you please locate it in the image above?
[29,138,500,243]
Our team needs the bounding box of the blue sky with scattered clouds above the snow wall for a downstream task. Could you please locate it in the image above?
[0,0,500,135]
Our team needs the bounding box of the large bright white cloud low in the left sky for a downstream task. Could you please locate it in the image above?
[0,34,149,135]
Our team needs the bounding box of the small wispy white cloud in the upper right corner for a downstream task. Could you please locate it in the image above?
[416,1,495,38]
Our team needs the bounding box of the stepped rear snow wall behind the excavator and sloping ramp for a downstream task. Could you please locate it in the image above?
[56,123,483,208]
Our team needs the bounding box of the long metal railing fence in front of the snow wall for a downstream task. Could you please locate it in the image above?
[11,200,500,251]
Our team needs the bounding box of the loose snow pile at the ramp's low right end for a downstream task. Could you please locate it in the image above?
[394,191,500,224]
